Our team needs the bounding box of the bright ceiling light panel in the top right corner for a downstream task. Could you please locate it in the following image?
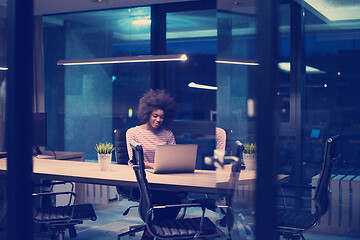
[297,0,360,21]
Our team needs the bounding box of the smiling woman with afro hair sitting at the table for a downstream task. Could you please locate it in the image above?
[126,90,180,240]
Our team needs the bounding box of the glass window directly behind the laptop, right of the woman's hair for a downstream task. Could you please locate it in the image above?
[165,9,217,169]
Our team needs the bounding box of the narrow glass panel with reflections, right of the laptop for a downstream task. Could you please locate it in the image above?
[216,4,258,238]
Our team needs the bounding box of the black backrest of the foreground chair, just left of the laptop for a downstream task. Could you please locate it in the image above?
[130,142,153,222]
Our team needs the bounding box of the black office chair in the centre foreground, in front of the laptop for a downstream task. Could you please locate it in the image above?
[130,141,224,239]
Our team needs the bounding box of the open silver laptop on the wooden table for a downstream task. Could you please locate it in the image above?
[146,144,197,173]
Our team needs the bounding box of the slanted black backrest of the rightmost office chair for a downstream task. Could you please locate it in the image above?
[314,135,339,216]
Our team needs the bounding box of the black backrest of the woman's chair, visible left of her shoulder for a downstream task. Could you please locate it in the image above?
[114,129,129,164]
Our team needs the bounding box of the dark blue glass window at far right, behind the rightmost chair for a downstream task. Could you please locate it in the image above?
[304,8,360,172]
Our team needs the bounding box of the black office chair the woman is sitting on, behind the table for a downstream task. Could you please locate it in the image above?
[114,129,146,239]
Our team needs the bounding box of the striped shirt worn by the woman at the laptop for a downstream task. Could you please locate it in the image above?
[126,126,176,163]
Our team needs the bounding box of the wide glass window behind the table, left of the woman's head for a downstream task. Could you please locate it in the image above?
[43,7,151,159]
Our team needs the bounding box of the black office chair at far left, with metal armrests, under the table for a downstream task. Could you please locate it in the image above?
[33,182,97,240]
